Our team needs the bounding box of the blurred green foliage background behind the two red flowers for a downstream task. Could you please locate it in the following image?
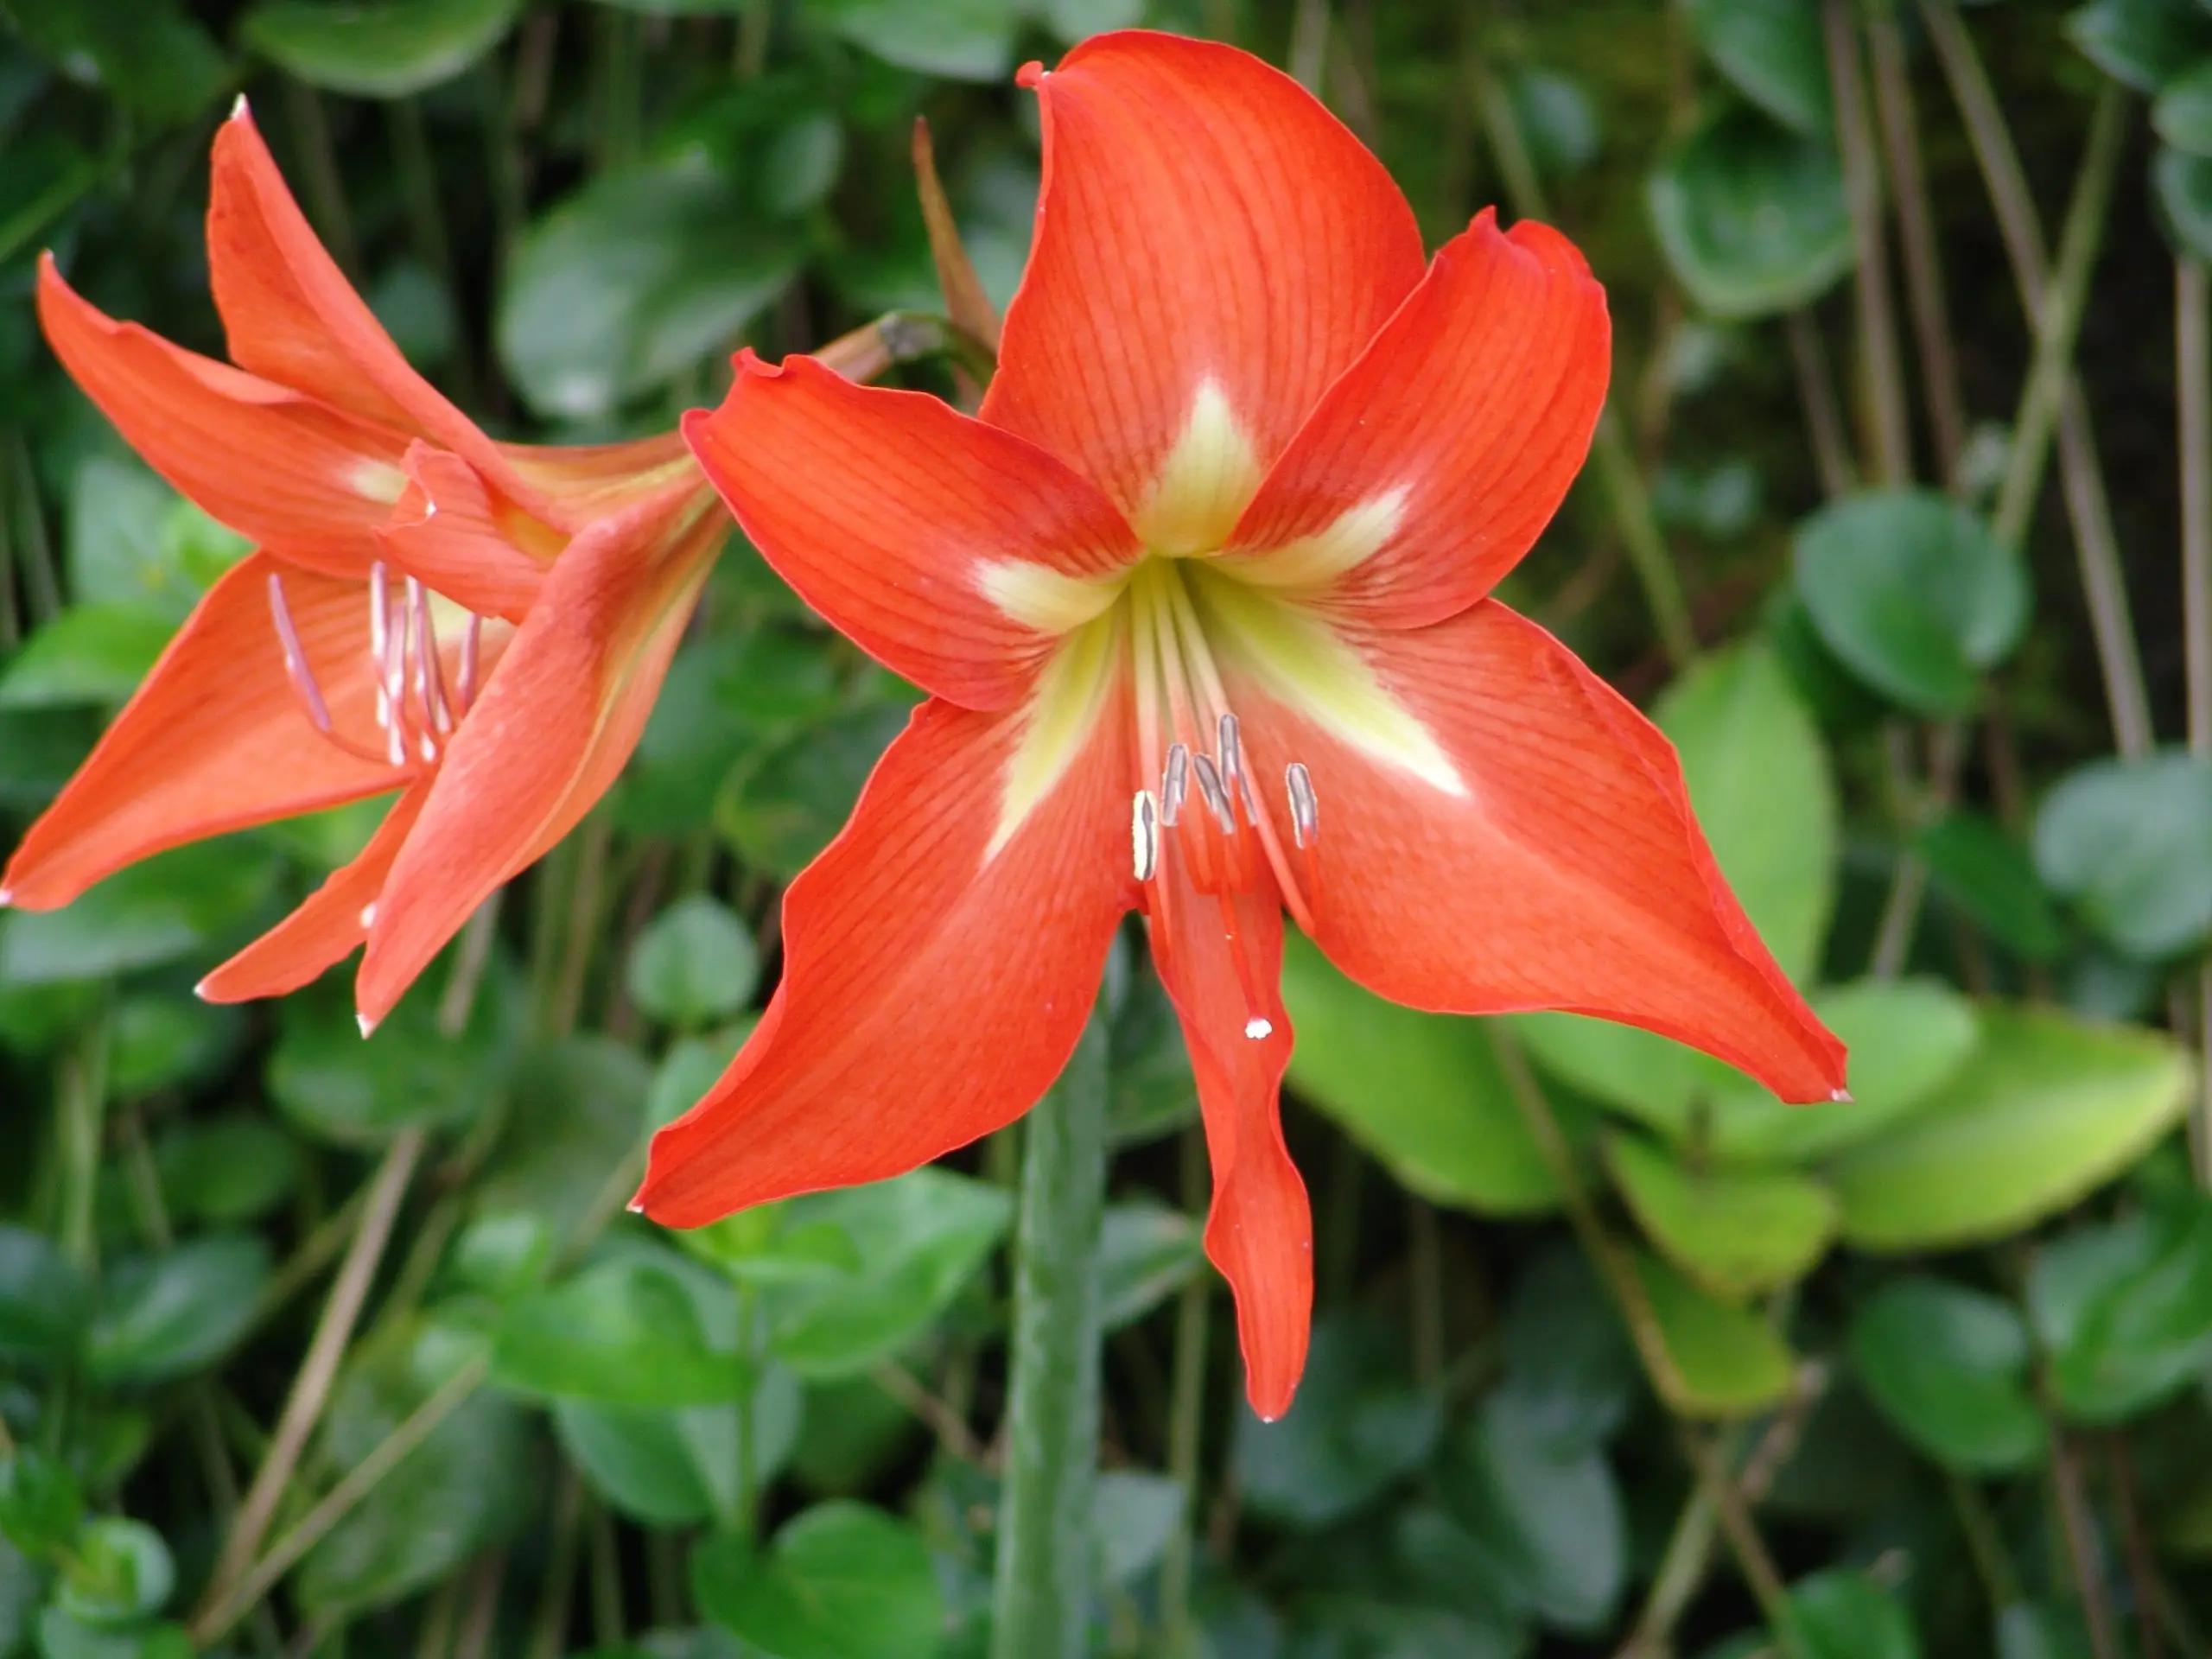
[0,0,2212,1659]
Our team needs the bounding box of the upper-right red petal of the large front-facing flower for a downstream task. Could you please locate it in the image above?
[1230,210,1612,628]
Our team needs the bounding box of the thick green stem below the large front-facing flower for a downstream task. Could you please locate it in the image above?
[991,1018,1106,1659]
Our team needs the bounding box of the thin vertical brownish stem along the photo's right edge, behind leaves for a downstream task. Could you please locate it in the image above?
[2174,259,2212,1188]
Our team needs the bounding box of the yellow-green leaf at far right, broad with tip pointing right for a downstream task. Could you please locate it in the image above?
[1832,1004,2190,1249]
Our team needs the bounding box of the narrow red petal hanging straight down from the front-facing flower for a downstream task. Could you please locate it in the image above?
[1153,836,1314,1422]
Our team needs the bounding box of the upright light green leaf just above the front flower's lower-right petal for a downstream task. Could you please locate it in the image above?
[1652,644,1836,980]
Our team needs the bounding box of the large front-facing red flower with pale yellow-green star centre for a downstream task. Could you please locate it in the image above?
[639,33,1842,1415]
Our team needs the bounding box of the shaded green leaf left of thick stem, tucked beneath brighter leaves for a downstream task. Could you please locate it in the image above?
[553,1363,805,1529]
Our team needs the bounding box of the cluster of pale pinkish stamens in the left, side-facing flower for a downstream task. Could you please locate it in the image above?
[268,560,498,767]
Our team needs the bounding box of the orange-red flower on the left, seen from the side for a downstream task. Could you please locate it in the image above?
[0,102,728,1028]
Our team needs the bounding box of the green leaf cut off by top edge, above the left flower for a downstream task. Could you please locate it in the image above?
[238,0,522,98]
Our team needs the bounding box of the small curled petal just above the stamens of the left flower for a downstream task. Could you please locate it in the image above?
[376,442,562,621]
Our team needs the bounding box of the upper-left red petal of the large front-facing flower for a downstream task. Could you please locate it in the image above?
[683,352,1139,708]
